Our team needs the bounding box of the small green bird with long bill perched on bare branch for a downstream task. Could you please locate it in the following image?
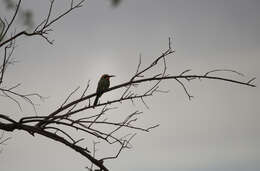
[94,74,114,106]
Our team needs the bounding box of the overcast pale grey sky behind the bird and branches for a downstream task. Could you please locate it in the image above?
[0,0,260,171]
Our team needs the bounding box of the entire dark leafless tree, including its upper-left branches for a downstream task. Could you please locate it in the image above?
[0,0,255,171]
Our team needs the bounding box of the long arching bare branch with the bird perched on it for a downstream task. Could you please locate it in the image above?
[34,36,255,126]
